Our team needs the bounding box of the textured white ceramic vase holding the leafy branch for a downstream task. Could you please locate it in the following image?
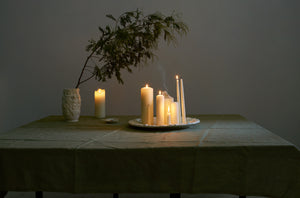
[62,88,81,122]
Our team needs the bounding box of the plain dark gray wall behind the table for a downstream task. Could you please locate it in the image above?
[0,0,300,146]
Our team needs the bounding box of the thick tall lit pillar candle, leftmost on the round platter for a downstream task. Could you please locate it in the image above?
[141,84,153,125]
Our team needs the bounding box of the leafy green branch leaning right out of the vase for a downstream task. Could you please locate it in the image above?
[76,10,188,87]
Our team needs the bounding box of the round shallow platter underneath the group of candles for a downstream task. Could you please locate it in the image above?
[128,117,200,130]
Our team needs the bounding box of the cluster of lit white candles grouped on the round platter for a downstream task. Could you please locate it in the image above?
[141,75,187,126]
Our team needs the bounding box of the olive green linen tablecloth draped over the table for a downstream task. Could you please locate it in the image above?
[0,115,300,198]
